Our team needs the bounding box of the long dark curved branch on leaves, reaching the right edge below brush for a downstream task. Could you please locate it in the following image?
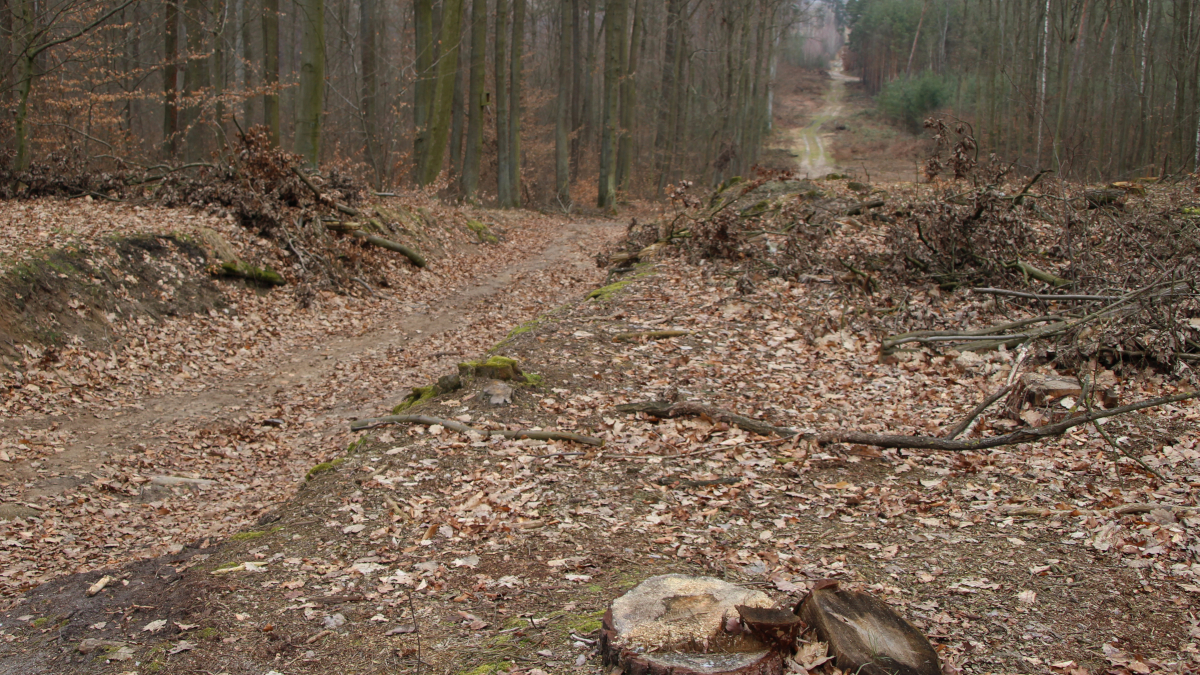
[815,392,1200,452]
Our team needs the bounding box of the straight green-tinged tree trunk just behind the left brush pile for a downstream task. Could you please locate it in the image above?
[295,0,325,168]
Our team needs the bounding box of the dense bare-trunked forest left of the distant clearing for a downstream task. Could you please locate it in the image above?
[0,0,806,208]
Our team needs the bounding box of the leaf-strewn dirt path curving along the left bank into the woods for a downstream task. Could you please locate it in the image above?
[0,214,622,593]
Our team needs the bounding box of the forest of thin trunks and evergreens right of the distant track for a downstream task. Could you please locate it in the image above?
[839,0,1200,180]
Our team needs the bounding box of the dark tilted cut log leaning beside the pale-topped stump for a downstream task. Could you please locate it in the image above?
[796,581,942,675]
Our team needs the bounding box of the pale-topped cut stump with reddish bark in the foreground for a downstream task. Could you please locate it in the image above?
[600,574,784,675]
